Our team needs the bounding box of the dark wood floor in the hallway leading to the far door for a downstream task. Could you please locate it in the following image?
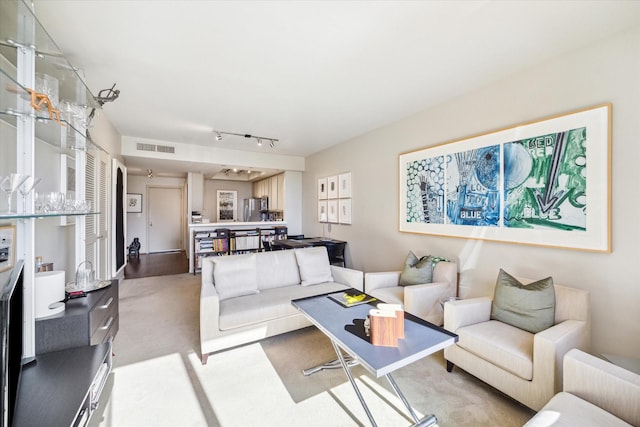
[124,251,189,279]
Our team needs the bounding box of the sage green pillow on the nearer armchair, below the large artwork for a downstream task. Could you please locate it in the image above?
[491,269,556,334]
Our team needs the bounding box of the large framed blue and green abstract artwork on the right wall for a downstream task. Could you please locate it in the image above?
[399,104,612,252]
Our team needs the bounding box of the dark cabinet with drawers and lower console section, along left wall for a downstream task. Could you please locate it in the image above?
[13,280,119,426]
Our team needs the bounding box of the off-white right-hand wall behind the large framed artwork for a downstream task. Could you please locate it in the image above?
[303,28,640,357]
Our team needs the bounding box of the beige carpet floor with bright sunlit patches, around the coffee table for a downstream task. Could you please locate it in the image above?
[90,274,533,427]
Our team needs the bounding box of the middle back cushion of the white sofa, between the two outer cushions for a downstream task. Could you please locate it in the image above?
[256,251,300,290]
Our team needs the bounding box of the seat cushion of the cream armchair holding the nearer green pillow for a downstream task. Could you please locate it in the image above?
[455,320,534,380]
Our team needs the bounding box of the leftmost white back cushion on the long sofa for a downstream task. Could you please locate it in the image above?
[212,254,258,301]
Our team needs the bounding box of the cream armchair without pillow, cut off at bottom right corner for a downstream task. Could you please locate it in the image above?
[525,349,640,427]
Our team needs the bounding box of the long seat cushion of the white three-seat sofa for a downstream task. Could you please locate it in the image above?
[219,282,349,331]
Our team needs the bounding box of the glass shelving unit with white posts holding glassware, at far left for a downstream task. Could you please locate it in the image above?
[0,0,103,364]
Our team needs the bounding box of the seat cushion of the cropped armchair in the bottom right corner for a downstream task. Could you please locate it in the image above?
[525,392,631,427]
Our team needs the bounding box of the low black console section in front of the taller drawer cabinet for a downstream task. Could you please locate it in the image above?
[12,341,112,427]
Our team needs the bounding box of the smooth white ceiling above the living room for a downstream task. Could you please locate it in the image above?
[35,0,640,178]
